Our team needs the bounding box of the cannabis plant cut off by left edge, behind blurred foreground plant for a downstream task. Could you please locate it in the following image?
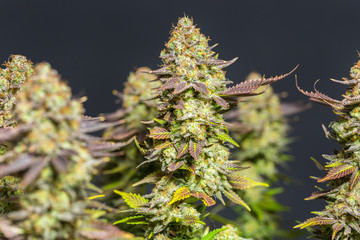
[0,55,33,215]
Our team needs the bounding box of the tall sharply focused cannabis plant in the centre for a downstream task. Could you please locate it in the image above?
[116,17,296,240]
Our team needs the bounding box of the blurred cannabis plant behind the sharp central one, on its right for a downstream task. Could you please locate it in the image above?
[226,72,303,239]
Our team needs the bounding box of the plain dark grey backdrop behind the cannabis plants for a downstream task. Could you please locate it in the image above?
[0,0,360,239]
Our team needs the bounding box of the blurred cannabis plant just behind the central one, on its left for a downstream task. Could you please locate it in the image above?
[99,67,159,200]
